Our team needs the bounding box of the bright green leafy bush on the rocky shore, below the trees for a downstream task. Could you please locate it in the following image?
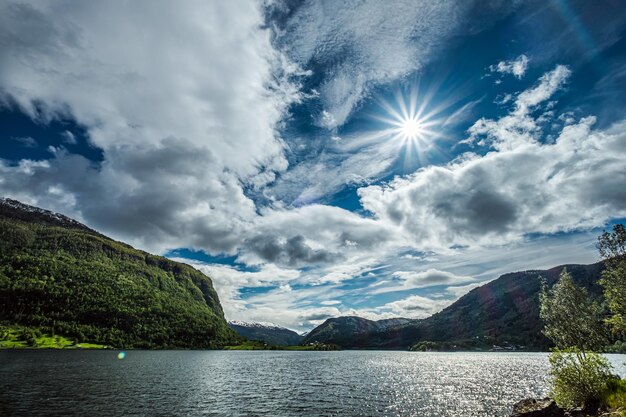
[549,348,614,408]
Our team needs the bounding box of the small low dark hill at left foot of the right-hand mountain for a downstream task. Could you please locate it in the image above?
[302,316,411,348]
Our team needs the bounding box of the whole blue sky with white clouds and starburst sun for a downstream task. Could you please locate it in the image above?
[0,0,626,331]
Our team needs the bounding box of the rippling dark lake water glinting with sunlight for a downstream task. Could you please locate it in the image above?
[0,350,626,417]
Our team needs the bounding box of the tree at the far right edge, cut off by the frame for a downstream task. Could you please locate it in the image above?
[596,224,626,334]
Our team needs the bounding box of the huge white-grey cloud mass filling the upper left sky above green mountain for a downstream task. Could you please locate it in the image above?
[0,0,299,252]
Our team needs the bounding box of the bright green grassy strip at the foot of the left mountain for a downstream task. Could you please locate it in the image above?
[0,326,106,349]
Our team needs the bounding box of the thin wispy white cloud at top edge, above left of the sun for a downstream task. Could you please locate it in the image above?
[274,0,516,129]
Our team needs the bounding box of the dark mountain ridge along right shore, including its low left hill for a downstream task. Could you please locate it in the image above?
[304,262,604,350]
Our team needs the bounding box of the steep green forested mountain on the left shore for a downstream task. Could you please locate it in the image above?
[0,199,241,348]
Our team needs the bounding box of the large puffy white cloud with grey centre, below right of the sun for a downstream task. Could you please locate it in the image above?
[359,66,626,251]
